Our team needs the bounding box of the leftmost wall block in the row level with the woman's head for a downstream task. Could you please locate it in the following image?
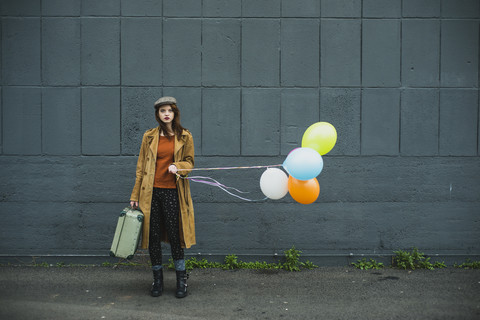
[2,87,42,155]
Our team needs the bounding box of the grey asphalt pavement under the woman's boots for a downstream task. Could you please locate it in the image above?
[0,266,480,320]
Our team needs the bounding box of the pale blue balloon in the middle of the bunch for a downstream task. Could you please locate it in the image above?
[283,148,323,180]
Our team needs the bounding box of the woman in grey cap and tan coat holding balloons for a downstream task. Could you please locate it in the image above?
[130,97,195,298]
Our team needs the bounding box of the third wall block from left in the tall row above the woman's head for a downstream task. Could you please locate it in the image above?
[82,18,120,85]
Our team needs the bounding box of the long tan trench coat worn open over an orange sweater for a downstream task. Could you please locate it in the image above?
[130,127,196,249]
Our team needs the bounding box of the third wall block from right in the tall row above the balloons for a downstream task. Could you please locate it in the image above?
[362,20,400,87]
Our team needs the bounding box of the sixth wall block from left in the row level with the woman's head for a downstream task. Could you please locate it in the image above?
[202,88,241,156]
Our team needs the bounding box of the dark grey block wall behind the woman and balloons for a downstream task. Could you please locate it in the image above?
[0,0,480,263]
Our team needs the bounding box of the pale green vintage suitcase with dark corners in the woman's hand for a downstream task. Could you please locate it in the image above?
[110,207,143,259]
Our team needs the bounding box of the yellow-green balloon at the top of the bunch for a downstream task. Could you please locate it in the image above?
[302,122,337,155]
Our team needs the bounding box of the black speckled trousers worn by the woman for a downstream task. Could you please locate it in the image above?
[148,188,184,266]
